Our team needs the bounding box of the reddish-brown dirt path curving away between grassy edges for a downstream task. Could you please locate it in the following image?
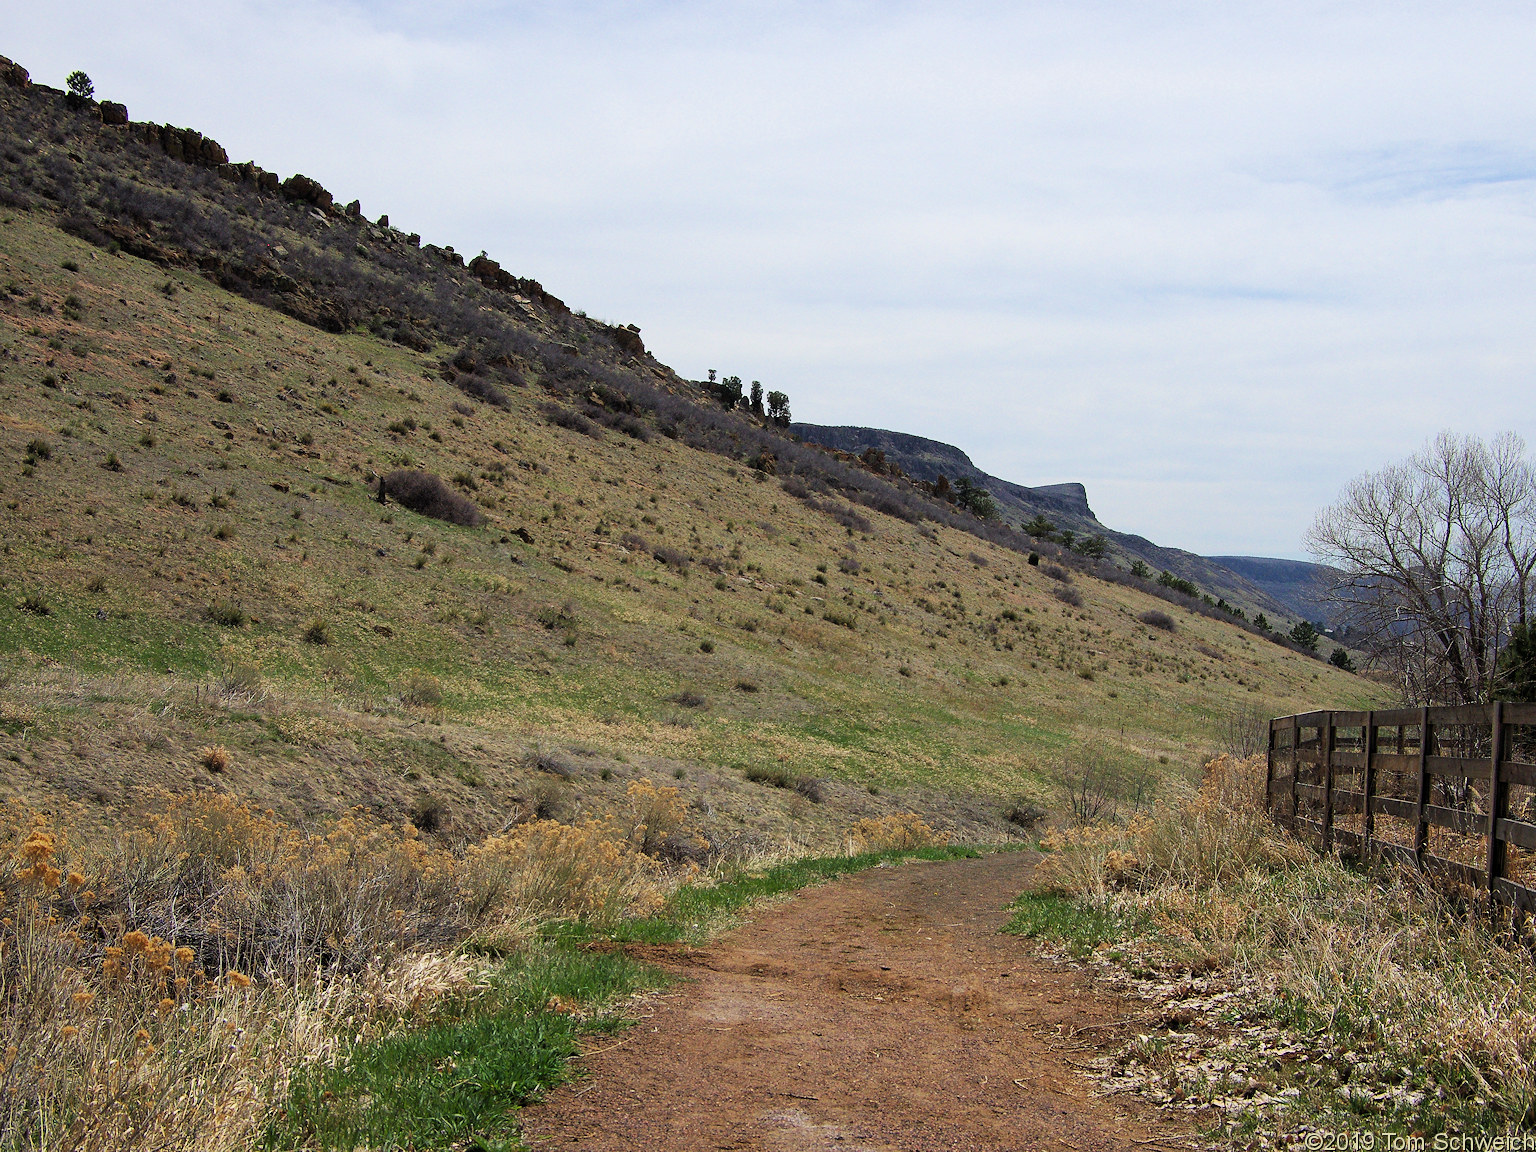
[524,852,1190,1152]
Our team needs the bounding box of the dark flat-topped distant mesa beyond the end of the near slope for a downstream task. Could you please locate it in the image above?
[790,424,1322,624]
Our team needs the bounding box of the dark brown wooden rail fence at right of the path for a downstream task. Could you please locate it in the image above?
[1266,703,1536,912]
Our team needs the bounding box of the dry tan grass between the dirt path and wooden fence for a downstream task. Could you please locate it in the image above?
[1012,756,1536,1132]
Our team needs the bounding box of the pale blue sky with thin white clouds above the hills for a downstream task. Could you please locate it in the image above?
[0,0,1536,558]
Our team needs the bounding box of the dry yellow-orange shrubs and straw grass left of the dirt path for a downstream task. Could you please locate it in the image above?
[0,788,684,1152]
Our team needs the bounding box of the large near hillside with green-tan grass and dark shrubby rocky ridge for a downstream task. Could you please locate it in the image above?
[0,56,1376,845]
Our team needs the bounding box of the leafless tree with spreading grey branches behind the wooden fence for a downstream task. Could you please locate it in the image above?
[1307,432,1536,703]
